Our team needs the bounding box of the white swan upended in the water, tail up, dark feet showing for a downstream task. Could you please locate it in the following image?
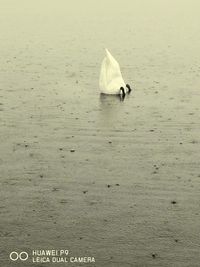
[99,49,131,97]
